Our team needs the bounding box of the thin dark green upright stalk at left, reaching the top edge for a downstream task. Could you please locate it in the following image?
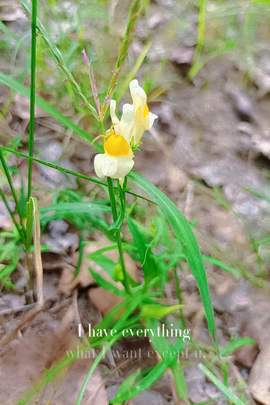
[27,0,37,199]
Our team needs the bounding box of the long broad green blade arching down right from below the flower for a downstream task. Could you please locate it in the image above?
[129,173,215,339]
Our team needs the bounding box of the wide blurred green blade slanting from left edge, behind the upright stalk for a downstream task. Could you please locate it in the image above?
[0,72,94,147]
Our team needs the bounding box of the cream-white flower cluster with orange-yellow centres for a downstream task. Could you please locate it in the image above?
[94,80,157,179]
